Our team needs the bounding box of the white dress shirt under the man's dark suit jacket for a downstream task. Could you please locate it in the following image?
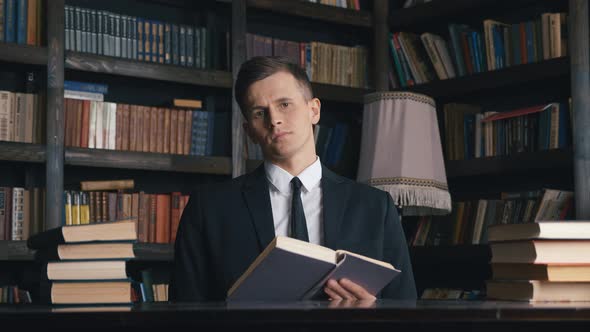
[264,157,324,245]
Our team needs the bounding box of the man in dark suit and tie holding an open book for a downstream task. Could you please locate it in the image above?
[170,57,416,301]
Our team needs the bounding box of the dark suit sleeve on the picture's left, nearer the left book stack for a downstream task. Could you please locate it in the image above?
[170,192,209,302]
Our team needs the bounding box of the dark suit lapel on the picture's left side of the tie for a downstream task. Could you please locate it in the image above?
[242,165,275,251]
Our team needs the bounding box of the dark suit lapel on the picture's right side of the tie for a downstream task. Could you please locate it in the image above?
[322,164,350,249]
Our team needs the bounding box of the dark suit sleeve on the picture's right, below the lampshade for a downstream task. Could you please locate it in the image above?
[381,192,417,300]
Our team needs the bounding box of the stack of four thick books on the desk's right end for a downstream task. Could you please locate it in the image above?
[487,221,590,302]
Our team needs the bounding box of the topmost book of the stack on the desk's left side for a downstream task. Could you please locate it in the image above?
[27,219,137,249]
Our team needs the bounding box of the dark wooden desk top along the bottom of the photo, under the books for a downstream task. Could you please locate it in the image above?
[0,301,590,332]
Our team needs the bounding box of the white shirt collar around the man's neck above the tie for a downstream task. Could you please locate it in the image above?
[264,157,322,194]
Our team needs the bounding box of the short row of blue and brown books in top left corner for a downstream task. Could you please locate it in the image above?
[0,0,44,46]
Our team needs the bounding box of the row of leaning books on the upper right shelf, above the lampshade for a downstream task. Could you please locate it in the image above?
[389,13,567,88]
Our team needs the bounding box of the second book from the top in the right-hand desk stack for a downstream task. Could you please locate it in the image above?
[490,240,590,264]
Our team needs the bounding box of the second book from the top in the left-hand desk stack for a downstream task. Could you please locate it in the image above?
[35,242,135,261]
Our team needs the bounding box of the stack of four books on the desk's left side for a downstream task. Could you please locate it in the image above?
[27,220,141,305]
